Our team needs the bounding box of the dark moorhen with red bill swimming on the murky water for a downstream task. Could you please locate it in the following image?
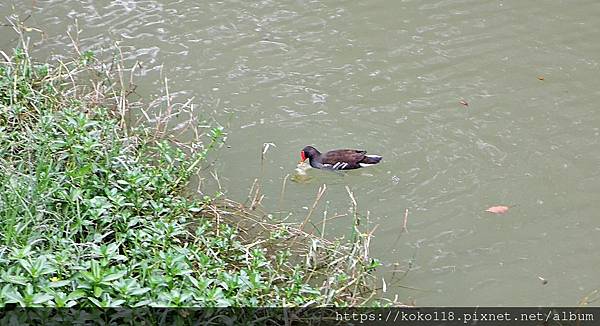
[300,146,382,170]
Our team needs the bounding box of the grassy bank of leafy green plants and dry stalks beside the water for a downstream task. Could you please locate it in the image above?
[0,29,378,314]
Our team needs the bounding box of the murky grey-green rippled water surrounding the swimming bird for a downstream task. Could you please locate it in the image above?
[0,0,600,306]
